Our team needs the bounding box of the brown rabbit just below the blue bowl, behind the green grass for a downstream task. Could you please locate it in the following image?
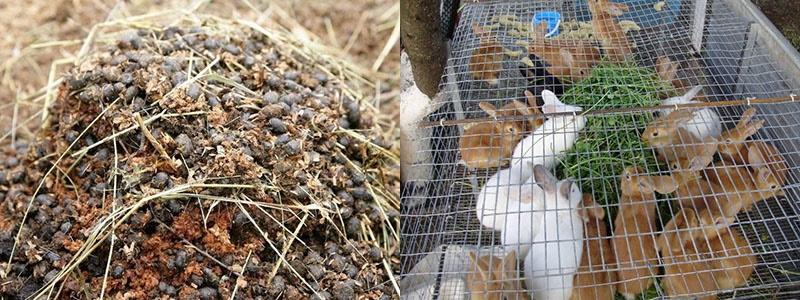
[528,23,602,81]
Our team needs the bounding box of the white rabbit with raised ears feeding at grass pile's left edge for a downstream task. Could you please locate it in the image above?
[511,90,586,170]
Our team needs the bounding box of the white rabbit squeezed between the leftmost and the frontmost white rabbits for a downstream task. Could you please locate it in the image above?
[500,166,545,258]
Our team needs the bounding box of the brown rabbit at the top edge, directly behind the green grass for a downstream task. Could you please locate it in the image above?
[588,0,633,62]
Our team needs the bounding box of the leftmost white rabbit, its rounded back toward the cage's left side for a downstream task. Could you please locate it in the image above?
[475,163,533,230]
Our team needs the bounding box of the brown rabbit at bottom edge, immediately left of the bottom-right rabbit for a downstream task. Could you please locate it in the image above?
[658,208,719,299]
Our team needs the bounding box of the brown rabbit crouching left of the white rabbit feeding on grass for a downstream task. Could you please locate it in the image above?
[458,100,537,168]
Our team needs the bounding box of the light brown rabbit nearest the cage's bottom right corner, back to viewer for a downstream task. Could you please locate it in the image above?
[695,210,758,289]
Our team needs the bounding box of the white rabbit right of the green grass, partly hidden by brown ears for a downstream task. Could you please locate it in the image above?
[658,85,722,140]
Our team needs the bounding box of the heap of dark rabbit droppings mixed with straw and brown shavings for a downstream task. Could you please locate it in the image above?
[0,20,399,299]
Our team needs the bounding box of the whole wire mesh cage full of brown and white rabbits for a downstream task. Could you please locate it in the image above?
[400,0,800,299]
